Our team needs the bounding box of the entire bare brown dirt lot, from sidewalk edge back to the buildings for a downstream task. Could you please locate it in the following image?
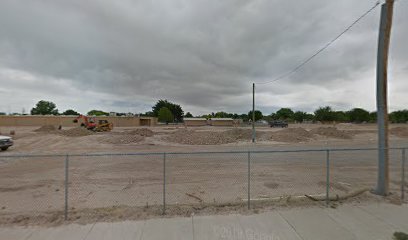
[0,124,408,224]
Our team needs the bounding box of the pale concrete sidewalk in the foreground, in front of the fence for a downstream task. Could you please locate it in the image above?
[0,203,408,240]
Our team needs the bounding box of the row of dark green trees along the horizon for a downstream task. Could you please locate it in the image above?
[7,99,408,123]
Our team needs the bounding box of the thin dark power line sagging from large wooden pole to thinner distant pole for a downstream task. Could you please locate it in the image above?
[256,1,380,84]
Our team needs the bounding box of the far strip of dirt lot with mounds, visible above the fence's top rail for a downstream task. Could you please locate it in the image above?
[0,124,408,154]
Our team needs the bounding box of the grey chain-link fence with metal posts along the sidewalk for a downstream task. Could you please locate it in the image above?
[0,148,407,223]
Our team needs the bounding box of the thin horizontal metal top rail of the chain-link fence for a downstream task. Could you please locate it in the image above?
[0,147,408,159]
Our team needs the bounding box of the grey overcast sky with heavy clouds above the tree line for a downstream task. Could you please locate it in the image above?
[0,0,408,114]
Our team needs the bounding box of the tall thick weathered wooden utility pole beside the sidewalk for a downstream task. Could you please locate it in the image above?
[375,0,394,196]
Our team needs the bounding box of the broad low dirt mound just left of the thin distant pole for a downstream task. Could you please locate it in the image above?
[166,129,236,145]
